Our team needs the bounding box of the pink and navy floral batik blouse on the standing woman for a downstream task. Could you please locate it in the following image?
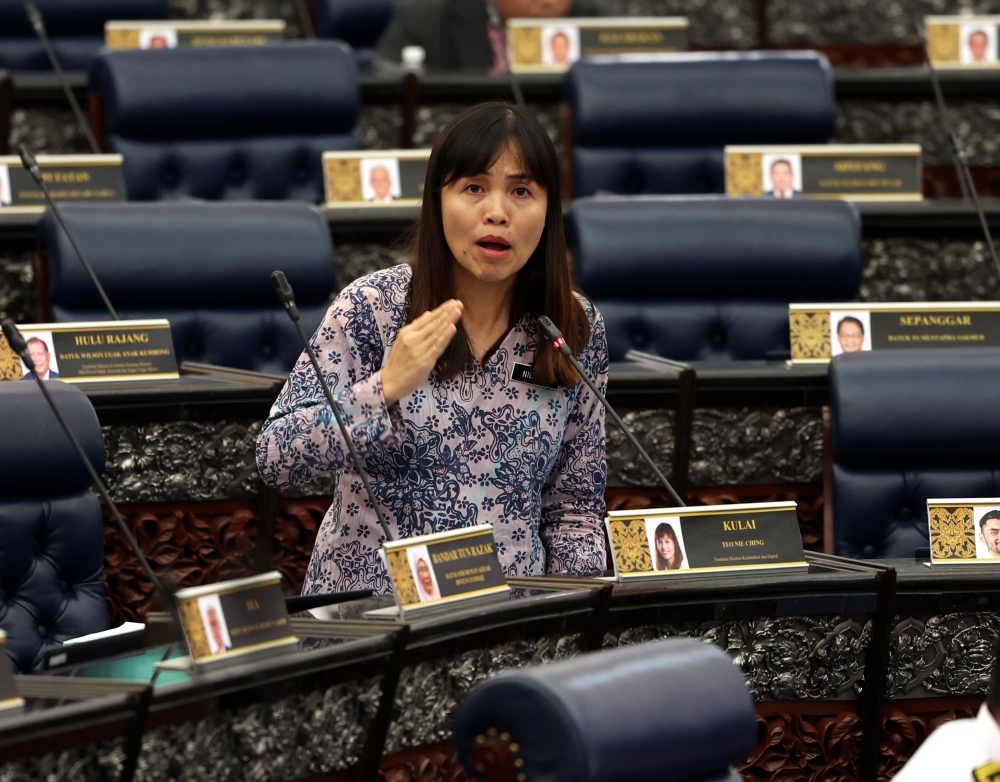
[257,265,608,594]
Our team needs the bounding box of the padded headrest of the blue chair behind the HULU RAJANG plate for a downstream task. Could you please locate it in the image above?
[36,201,336,309]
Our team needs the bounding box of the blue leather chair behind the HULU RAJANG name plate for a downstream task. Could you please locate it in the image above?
[36,203,336,373]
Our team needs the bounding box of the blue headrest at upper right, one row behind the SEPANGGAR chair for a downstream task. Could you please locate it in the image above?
[564,52,837,147]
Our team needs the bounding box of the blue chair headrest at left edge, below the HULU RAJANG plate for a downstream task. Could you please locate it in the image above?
[0,380,104,497]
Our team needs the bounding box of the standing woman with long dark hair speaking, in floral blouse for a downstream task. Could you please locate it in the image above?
[257,103,608,594]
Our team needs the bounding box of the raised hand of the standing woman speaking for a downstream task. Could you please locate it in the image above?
[382,299,462,405]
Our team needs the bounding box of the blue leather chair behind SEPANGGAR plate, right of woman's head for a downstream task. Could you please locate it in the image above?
[566,196,862,361]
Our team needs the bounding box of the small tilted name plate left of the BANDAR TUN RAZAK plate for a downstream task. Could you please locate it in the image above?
[176,571,298,668]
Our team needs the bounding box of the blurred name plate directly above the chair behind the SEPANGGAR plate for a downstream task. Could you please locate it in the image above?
[725,144,923,201]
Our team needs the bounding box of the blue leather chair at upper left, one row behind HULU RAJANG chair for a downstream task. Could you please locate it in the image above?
[90,41,362,203]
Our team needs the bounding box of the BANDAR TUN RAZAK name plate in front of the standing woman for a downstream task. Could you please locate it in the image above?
[382,524,510,616]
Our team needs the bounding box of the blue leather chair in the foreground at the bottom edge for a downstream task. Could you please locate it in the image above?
[454,639,757,782]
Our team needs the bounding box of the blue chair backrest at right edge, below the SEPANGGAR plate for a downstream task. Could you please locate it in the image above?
[829,348,1000,559]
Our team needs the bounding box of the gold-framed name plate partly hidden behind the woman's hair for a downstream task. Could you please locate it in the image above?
[323,149,431,208]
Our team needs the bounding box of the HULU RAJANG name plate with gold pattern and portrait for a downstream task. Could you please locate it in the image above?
[0,320,178,383]
